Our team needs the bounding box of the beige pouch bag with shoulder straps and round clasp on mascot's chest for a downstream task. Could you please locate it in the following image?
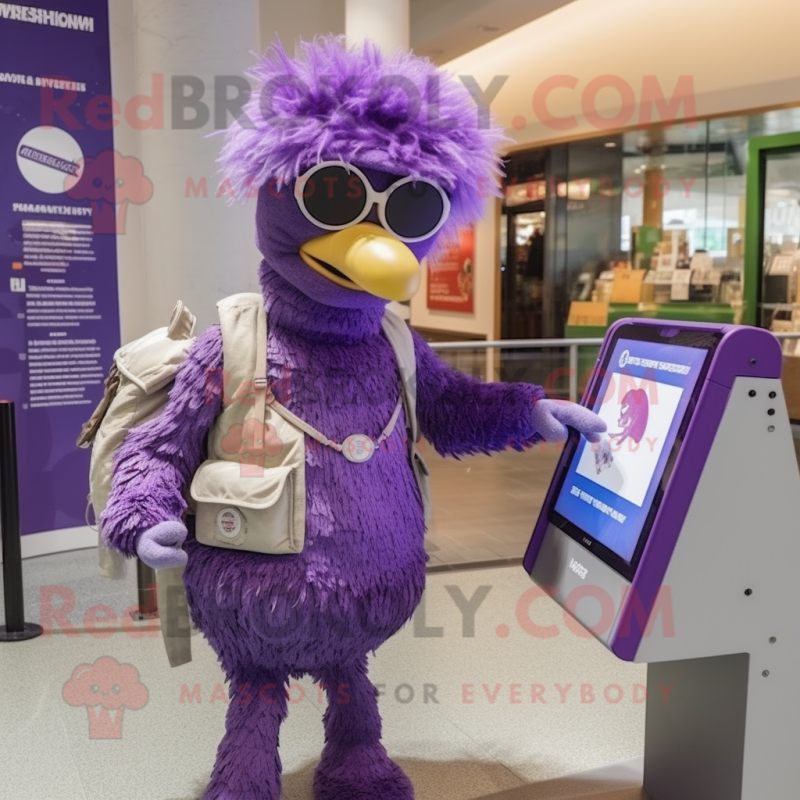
[189,293,430,555]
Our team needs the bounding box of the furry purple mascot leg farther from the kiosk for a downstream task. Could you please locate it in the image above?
[203,670,287,800]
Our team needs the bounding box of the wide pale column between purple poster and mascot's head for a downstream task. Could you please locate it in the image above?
[114,0,260,330]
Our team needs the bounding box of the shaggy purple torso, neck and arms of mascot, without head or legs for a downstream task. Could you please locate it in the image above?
[103,260,541,676]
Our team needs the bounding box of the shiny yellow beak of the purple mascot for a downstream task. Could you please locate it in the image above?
[300,222,421,301]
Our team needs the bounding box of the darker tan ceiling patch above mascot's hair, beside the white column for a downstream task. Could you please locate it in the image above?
[410,0,573,64]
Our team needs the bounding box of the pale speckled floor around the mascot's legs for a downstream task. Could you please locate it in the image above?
[0,550,645,800]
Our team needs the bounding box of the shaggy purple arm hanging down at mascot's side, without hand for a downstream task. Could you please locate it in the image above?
[100,325,222,556]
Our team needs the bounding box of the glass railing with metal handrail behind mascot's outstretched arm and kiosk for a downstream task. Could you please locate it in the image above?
[423,332,800,570]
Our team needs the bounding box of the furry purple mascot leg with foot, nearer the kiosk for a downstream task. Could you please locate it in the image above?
[314,656,414,800]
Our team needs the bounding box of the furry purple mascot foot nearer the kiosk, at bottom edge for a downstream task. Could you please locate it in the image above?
[314,744,414,800]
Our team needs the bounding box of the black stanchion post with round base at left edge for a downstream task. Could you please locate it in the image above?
[0,400,42,642]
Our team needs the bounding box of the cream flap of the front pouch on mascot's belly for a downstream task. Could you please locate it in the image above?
[189,460,293,509]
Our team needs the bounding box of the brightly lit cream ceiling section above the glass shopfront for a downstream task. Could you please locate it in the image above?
[446,0,800,147]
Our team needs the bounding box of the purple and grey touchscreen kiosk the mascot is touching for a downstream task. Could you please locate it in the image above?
[525,320,800,800]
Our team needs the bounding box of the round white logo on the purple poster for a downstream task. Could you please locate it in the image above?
[16,126,83,194]
